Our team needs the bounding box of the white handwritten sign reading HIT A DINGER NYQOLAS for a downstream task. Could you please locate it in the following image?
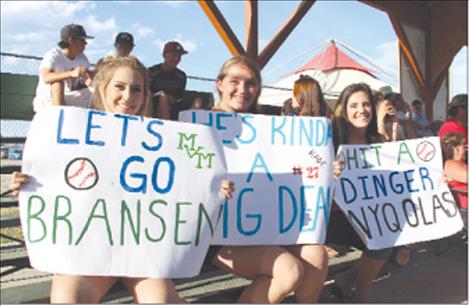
[330,137,463,249]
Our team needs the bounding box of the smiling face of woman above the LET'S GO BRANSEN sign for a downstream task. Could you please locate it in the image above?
[101,66,145,115]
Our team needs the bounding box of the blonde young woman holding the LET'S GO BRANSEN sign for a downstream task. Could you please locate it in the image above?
[10,56,232,303]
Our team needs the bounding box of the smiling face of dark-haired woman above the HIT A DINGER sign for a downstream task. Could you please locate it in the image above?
[346,91,373,128]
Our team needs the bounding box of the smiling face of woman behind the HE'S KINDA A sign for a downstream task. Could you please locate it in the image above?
[217,64,260,113]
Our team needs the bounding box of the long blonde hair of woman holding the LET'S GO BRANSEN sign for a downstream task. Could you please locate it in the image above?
[91,55,152,116]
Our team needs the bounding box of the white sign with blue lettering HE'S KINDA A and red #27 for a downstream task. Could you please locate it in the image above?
[179,110,333,245]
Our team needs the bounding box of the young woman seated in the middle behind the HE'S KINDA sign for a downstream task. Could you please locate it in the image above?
[211,56,328,303]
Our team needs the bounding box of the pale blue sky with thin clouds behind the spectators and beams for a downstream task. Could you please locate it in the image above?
[1,1,467,96]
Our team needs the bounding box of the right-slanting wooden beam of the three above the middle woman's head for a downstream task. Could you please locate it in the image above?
[258,0,316,68]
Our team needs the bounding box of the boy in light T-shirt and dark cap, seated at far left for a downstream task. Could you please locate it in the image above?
[33,24,93,111]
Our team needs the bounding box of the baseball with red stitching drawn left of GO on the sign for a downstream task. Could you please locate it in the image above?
[65,157,98,190]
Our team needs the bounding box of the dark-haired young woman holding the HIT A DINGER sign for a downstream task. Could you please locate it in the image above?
[327,83,397,303]
